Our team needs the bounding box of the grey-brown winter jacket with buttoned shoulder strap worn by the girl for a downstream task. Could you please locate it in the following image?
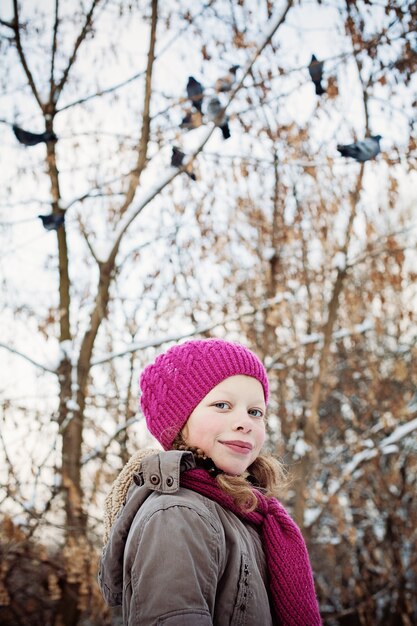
[99,451,273,626]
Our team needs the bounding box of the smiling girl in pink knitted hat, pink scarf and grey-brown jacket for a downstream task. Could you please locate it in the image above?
[99,339,321,626]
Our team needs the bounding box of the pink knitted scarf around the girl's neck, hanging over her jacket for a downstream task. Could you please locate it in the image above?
[181,469,322,626]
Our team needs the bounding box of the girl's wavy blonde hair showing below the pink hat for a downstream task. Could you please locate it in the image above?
[172,433,288,512]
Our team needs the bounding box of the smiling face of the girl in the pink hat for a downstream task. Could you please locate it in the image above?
[182,375,266,475]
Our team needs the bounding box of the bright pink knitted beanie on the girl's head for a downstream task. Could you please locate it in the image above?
[140,339,269,450]
